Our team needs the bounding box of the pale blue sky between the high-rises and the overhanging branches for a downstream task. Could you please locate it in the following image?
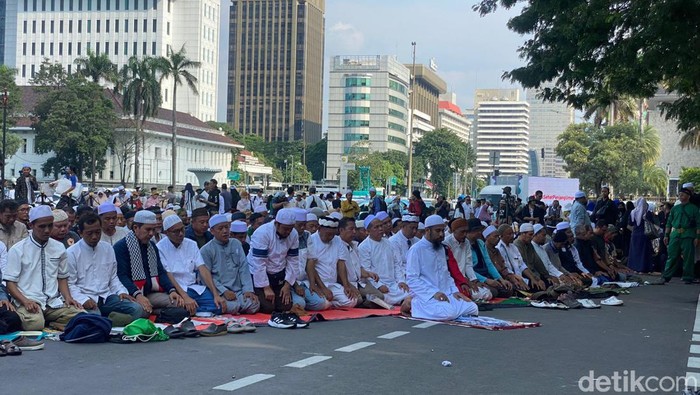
[219,0,525,125]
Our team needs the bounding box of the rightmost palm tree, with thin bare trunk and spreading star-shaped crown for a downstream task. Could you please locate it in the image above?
[158,44,202,186]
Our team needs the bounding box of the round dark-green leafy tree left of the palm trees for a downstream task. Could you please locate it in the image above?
[34,78,117,186]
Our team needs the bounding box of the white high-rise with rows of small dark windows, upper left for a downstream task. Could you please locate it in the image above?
[2,0,220,121]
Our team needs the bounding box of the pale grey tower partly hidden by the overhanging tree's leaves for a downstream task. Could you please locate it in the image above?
[526,90,574,178]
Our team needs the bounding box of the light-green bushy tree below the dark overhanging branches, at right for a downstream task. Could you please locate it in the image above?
[556,123,667,194]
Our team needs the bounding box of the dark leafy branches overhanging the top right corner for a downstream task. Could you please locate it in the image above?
[474,0,700,143]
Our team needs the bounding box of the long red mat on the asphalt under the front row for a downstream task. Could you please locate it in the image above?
[192,308,401,330]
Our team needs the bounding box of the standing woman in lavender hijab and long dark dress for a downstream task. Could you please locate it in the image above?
[627,198,654,273]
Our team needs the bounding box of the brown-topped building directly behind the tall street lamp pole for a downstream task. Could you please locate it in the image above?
[404,63,447,141]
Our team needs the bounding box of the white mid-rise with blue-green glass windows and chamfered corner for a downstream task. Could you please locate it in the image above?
[326,55,410,180]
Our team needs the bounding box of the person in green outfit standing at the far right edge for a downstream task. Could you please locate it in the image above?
[663,188,700,284]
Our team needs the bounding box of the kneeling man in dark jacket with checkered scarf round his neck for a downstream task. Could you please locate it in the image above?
[114,210,188,316]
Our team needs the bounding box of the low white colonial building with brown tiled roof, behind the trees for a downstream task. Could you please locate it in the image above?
[5,86,243,188]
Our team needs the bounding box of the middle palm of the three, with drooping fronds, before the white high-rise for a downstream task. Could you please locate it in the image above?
[118,56,162,187]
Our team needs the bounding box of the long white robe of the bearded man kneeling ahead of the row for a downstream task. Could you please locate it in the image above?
[406,239,479,321]
